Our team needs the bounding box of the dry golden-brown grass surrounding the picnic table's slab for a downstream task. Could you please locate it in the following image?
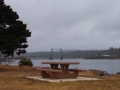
[0,65,120,90]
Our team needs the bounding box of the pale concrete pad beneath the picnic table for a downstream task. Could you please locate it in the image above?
[27,76,100,82]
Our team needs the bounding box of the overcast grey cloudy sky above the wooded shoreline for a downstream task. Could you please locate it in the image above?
[5,0,120,52]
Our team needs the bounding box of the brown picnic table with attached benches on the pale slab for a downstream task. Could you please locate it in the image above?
[41,62,79,79]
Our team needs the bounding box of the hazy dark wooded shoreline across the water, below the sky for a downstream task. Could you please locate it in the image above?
[15,47,120,59]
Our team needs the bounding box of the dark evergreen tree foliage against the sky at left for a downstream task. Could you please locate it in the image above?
[0,0,31,57]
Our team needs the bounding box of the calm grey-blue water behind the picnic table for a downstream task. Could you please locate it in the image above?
[2,59,120,74]
